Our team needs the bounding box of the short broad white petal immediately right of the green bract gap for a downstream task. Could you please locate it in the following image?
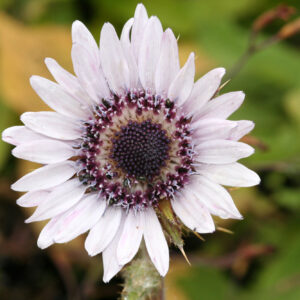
[171,191,215,233]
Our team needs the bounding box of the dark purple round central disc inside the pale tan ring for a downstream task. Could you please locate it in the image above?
[111,120,171,179]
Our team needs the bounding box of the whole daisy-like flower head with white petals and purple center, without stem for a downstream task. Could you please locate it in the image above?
[3,4,259,282]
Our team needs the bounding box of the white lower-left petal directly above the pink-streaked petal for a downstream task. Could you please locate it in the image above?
[26,178,86,223]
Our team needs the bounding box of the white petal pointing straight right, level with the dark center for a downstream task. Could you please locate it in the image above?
[196,140,254,164]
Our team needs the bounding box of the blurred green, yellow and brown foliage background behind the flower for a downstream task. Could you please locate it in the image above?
[0,0,300,300]
